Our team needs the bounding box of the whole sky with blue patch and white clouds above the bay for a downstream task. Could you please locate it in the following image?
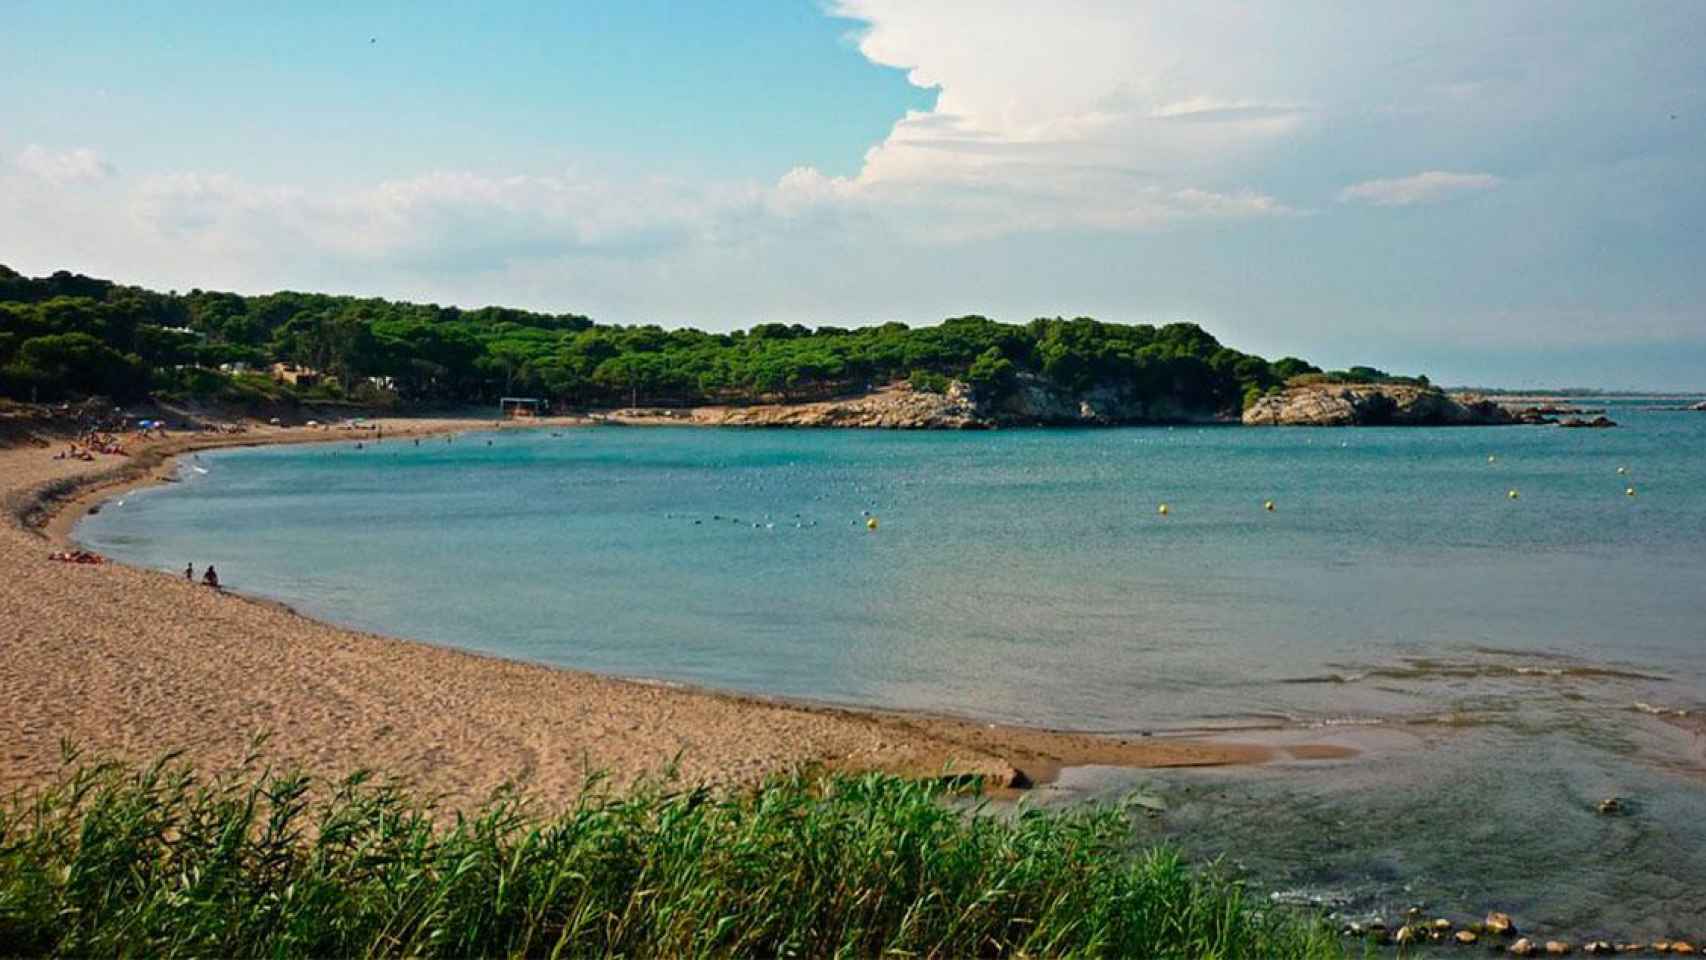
[0,0,1706,390]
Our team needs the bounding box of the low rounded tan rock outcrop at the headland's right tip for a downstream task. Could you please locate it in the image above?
[1244,384,1518,426]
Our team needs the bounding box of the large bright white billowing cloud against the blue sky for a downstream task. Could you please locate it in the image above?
[778,0,1310,233]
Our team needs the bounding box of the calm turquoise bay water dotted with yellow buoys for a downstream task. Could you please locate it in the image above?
[78,401,1706,936]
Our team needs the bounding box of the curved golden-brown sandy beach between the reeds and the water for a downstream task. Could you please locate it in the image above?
[0,412,1348,807]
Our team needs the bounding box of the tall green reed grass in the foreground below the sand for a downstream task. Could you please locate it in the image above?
[0,760,1339,958]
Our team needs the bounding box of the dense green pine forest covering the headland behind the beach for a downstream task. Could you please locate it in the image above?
[0,266,1380,413]
